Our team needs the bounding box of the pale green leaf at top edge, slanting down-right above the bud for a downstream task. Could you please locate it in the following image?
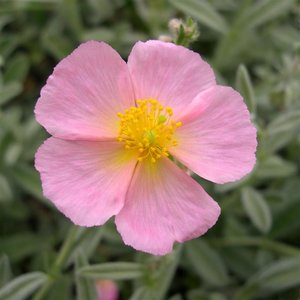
[169,0,228,33]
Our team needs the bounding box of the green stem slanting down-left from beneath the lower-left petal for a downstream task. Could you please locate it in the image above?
[33,226,78,300]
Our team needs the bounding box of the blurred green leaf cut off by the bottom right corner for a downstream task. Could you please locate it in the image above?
[248,258,300,296]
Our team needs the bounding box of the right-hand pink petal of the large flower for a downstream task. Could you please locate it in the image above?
[172,86,257,183]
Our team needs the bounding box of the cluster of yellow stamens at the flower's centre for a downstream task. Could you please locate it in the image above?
[117,99,182,163]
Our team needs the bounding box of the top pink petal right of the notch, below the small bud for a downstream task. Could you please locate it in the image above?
[128,41,216,114]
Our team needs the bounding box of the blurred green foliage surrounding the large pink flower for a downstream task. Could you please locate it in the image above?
[0,0,300,300]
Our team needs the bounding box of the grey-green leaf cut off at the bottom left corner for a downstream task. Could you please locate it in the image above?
[0,272,47,300]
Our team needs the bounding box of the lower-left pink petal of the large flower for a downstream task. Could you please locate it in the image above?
[35,138,136,226]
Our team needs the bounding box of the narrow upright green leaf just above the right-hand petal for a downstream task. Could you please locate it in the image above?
[235,65,256,114]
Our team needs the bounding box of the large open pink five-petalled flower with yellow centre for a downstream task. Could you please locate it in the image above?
[35,41,256,255]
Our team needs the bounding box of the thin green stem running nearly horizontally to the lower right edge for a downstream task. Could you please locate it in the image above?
[211,237,300,257]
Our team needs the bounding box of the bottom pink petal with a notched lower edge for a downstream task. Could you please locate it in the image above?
[116,158,220,255]
